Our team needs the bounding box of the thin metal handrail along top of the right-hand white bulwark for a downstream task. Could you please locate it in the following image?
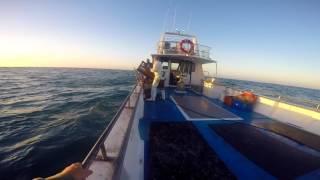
[214,82,320,112]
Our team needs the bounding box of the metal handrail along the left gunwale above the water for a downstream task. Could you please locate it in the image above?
[82,84,137,168]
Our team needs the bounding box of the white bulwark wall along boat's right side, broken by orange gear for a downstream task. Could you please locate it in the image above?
[203,84,320,135]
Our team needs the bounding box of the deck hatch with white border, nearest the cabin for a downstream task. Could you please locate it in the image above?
[171,96,242,120]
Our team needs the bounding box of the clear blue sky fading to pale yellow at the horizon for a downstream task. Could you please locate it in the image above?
[0,0,320,89]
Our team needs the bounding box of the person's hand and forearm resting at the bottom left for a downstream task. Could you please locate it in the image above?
[33,163,92,180]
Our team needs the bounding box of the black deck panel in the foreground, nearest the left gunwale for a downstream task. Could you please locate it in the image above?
[145,122,236,179]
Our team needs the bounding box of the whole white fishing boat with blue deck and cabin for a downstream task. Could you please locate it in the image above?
[82,32,320,179]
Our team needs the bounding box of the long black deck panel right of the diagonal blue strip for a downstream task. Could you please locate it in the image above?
[210,123,320,179]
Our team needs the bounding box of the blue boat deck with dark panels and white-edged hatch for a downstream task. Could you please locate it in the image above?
[138,88,320,179]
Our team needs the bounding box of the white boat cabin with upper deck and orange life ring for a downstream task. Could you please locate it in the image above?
[151,32,217,87]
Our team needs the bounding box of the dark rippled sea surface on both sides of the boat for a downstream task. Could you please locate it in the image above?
[0,68,320,180]
